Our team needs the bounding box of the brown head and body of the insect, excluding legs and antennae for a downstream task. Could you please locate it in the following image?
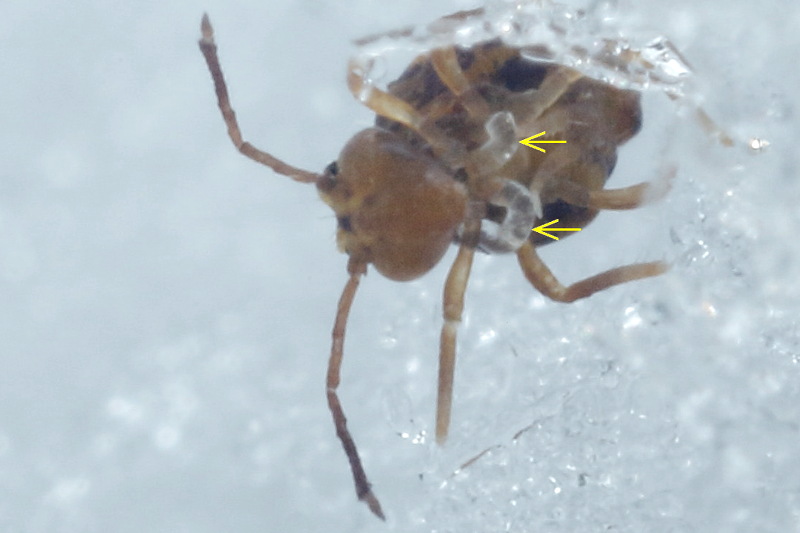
[319,40,641,270]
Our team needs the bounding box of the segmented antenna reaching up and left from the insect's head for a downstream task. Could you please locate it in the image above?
[198,15,317,183]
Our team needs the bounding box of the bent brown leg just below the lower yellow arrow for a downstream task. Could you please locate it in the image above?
[517,241,669,303]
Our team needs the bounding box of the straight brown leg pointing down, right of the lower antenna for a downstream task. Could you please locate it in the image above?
[436,211,481,445]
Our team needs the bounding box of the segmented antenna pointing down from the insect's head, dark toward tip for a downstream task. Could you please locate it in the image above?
[325,260,386,520]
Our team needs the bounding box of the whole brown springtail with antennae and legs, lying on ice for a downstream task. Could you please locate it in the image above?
[200,10,666,518]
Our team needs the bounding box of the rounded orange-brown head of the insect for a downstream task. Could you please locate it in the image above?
[317,128,467,281]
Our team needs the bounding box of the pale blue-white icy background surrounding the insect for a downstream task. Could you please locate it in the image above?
[0,0,800,533]
